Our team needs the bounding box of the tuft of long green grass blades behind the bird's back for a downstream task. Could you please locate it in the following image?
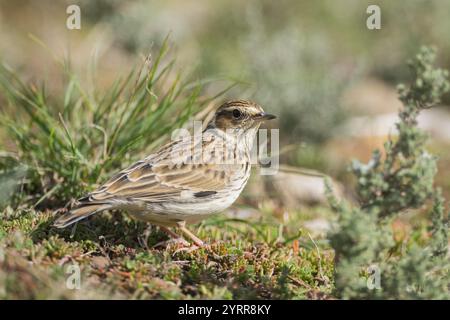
[0,39,230,207]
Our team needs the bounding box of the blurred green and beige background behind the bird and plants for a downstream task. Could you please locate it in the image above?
[0,0,450,206]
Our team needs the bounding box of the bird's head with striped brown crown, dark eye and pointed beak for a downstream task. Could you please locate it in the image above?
[210,100,276,132]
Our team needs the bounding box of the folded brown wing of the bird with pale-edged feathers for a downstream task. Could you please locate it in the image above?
[88,135,236,202]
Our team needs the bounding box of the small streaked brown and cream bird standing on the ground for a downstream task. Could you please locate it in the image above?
[54,100,276,247]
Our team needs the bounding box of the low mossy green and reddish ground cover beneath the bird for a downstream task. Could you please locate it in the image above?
[0,204,333,299]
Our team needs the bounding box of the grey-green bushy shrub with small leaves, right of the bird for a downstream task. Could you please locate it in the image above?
[329,47,450,299]
